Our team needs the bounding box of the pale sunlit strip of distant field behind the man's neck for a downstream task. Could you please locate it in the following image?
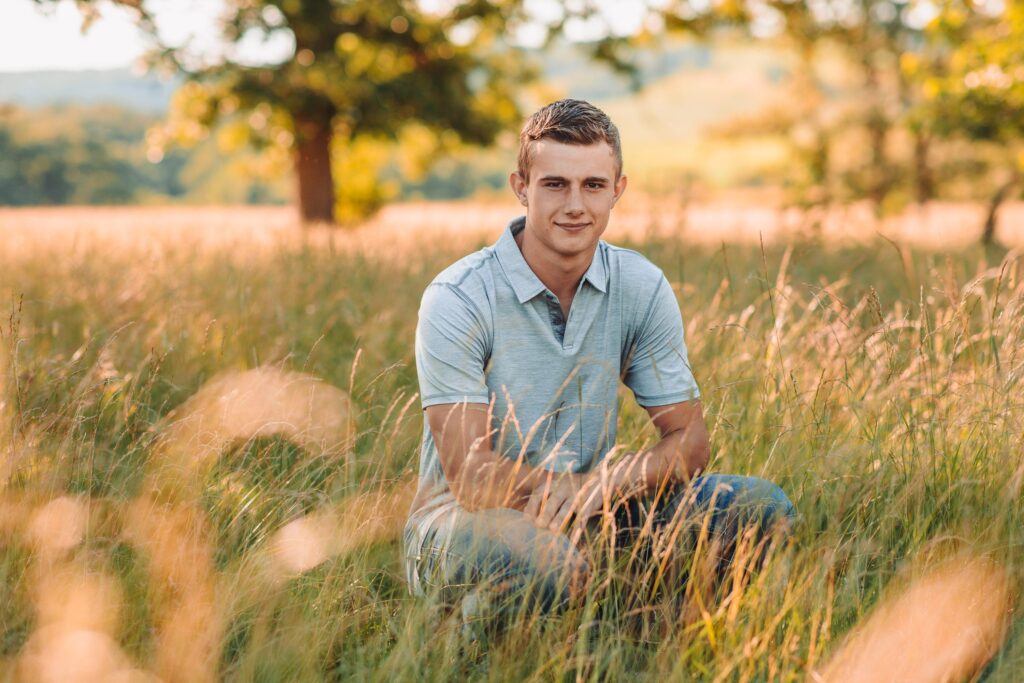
[0,200,1024,253]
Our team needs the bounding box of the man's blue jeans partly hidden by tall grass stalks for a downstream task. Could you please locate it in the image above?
[406,474,796,611]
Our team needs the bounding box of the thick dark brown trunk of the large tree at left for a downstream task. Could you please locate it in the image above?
[293,114,334,223]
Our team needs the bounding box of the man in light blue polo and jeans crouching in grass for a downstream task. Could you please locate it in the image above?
[403,99,795,638]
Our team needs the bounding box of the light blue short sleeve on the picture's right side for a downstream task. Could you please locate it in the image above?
[623,275,700,408]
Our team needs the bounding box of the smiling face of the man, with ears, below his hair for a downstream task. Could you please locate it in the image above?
[509,139,626,260]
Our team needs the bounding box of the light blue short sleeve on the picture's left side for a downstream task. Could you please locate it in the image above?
[416,284,488,408]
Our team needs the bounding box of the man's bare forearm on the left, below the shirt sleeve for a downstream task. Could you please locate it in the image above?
[426,403,558,511]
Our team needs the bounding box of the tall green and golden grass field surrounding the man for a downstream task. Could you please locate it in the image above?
[0,205,1024,681]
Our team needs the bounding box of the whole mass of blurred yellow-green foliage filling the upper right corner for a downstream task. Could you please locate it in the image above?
[650,0,1024,241]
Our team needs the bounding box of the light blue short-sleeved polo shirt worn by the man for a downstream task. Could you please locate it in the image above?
[407,217,700,561]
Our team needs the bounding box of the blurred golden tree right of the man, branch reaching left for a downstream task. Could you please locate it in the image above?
[614,0,983,213]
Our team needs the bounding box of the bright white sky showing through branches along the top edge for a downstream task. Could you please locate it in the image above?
[0,0,642,72]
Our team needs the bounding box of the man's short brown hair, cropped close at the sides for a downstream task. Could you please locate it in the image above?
[518,99,623,180]
